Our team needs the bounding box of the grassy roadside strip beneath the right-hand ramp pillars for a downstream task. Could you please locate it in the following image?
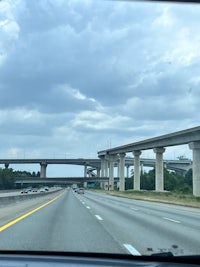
[88,190,200,208]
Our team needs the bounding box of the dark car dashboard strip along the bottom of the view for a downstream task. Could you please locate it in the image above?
[0,251,200,267]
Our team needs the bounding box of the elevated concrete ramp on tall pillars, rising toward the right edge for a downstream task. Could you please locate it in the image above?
[98,126,200,196]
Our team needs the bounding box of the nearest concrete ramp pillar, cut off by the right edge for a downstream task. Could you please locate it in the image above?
[189,142,200,197]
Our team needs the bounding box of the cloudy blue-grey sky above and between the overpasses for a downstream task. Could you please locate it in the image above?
[0,0,200,176]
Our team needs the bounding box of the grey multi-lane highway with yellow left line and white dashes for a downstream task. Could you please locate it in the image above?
[0,190,200,255]
